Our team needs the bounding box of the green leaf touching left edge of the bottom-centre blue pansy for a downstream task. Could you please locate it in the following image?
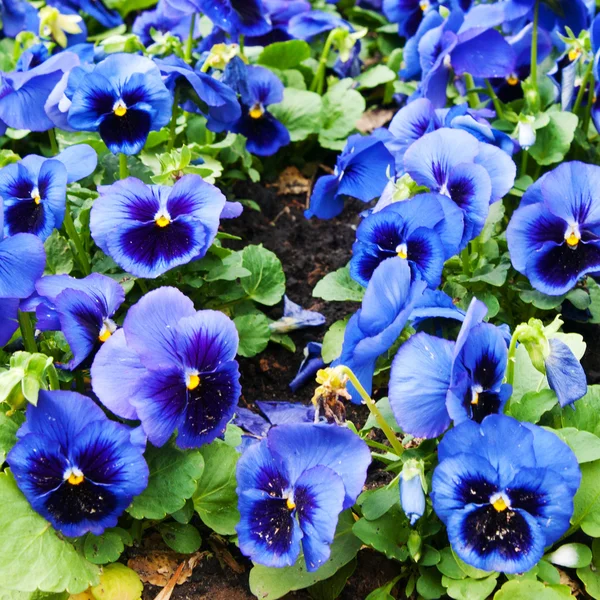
[193,440,240,535]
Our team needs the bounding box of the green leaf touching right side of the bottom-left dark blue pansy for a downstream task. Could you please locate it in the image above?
[128,445,204,519]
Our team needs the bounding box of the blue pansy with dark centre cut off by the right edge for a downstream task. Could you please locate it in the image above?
[506,162,600,296]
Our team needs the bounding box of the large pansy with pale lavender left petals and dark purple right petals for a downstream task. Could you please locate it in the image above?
[91,287,241,448]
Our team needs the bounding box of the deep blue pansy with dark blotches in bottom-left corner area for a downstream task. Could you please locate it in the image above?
[7,390,148,537]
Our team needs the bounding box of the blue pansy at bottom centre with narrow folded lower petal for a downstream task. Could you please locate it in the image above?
[236,424,371,572]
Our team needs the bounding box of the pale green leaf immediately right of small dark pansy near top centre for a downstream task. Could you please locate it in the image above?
[269,87,323,142]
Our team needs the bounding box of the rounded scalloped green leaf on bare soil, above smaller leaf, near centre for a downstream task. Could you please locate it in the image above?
[241,244,285,306]
